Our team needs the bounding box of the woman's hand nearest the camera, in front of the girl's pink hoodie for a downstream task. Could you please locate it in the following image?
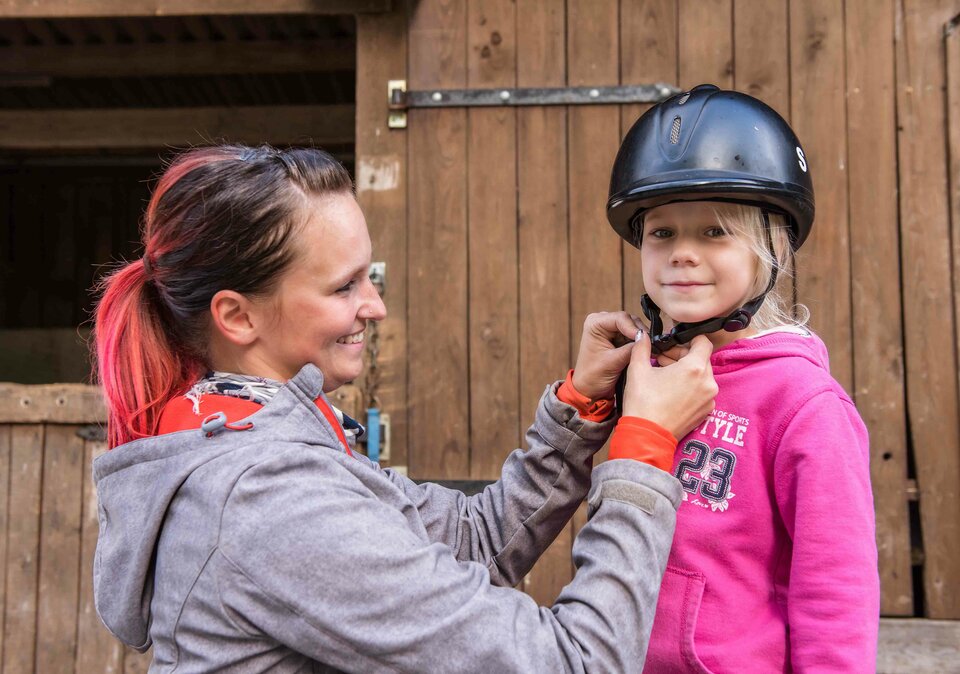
[623,334,717,439]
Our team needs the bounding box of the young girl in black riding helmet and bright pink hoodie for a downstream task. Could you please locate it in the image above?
[608,85,879,673]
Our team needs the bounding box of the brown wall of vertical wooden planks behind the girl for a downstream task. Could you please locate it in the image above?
[357,0,960,619]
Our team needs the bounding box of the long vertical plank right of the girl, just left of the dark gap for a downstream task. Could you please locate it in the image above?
[848,0,913,616]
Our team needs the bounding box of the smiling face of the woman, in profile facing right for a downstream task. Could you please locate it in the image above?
[258,194,387,392]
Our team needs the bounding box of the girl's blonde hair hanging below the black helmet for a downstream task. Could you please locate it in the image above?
[714,202,810,331]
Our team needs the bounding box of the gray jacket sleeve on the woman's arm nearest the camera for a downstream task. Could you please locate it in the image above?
[218,451,681,672]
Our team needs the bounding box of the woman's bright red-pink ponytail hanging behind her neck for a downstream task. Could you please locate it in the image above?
[94,260,201,448]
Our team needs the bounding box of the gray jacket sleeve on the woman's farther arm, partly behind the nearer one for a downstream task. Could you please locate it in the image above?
[385,384,614,587]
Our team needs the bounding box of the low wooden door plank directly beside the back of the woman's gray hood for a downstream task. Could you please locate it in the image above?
[76,441,123,674]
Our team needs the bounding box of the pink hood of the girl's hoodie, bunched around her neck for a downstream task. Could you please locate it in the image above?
[710,326,830,373]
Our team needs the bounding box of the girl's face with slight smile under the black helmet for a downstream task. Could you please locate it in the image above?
[640,201,757,342]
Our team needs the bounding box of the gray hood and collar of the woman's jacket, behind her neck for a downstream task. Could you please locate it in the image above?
[93,365,339,651]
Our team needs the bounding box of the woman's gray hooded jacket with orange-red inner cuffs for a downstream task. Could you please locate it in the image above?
[93,365,681,673]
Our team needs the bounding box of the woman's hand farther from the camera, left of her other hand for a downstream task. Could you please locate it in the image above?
[573,311,650,400]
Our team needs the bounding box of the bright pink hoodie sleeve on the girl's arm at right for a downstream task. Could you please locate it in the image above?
[774,390,880,672]
